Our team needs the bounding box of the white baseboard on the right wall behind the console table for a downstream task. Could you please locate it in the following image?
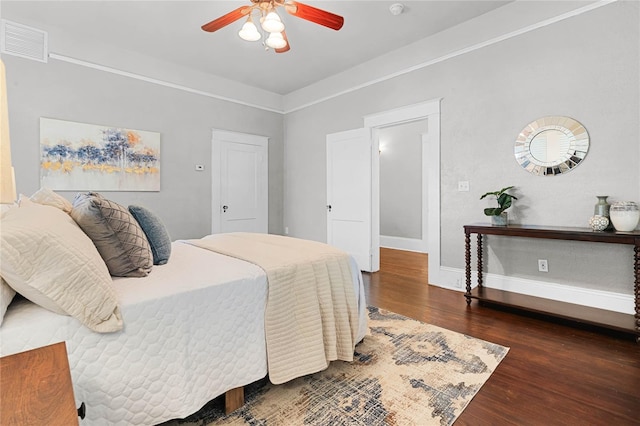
[429,267,635,314]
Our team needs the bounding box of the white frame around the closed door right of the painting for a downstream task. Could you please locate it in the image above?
[211,129,269,234]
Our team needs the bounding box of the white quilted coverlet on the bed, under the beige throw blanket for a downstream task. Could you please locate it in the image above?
[0,191,367,425]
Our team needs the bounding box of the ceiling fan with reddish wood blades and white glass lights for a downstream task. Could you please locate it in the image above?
[202,0,344,53]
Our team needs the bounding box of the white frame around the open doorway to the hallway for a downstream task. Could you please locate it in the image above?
[364,98,442,282]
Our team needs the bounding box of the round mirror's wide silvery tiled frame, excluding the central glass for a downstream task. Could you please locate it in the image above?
[513,116,589,176]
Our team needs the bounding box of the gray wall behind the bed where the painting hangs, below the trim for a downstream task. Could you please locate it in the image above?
[3,55,283,239]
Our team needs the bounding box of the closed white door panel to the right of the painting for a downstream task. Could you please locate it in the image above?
[212,130,269,233]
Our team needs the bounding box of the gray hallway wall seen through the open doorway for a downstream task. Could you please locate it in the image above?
[379,120,427,240]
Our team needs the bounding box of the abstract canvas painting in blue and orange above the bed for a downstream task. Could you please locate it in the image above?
[40,117,160,191]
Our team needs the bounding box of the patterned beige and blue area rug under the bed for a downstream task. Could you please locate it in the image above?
[171,307,509,426]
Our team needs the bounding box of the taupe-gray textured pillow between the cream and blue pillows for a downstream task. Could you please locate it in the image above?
[71,192,153,277]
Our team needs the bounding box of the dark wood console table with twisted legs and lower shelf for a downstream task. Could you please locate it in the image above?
[464,224,640,342]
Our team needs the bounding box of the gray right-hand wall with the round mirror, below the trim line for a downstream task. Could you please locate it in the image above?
[285,2,640,293]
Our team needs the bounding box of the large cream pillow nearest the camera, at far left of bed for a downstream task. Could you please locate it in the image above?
[0,199,123,333]
